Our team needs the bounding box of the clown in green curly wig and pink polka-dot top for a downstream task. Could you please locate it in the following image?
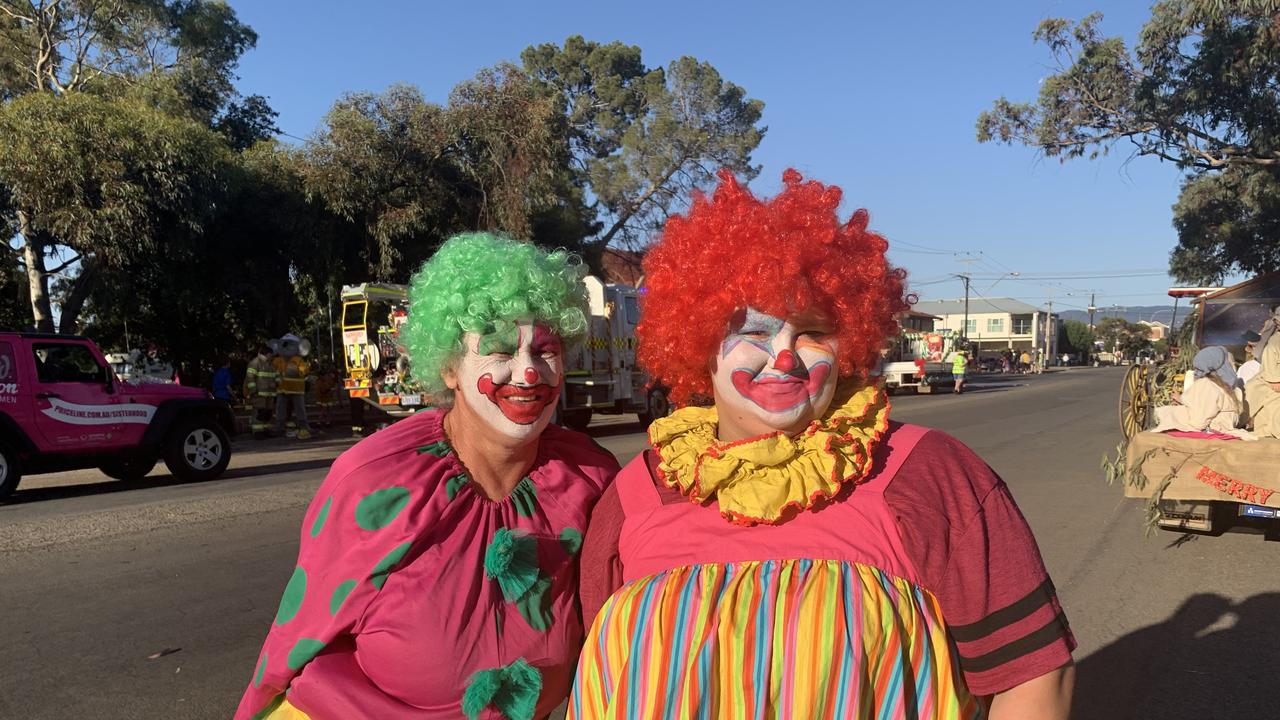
[236,233,618,720]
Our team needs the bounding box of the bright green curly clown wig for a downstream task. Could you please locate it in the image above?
[401,232,588,396]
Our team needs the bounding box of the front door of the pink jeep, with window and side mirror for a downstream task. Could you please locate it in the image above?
[31,340,133,452]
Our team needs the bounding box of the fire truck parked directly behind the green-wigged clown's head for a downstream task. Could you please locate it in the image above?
[342,275,671,429]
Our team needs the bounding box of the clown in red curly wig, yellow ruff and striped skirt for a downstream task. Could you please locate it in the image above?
[570,170,1075,720]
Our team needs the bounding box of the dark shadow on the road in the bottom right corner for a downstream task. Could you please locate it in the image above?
[1071,592,1280,720]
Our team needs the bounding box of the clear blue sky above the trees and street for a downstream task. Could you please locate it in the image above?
[230,0,1198,309]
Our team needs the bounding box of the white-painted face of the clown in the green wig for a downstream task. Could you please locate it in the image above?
[444,322,564,439]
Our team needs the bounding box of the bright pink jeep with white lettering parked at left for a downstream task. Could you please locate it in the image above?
[0,333,234,498]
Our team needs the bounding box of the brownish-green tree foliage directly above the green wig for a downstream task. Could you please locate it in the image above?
[305,65,568,282]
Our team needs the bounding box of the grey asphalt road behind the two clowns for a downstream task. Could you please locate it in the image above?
[0,369,1280,720]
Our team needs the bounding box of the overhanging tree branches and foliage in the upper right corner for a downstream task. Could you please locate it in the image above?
[978,0,1280,283]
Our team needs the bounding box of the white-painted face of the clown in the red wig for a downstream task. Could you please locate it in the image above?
[712,307,840,442]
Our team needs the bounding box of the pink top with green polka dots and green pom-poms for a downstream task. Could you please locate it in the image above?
[236,411,618,720]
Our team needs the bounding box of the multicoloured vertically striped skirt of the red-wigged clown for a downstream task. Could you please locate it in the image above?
[568,560,983,720]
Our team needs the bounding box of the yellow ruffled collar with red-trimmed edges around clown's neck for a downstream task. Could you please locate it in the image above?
[649,384,890,525]
